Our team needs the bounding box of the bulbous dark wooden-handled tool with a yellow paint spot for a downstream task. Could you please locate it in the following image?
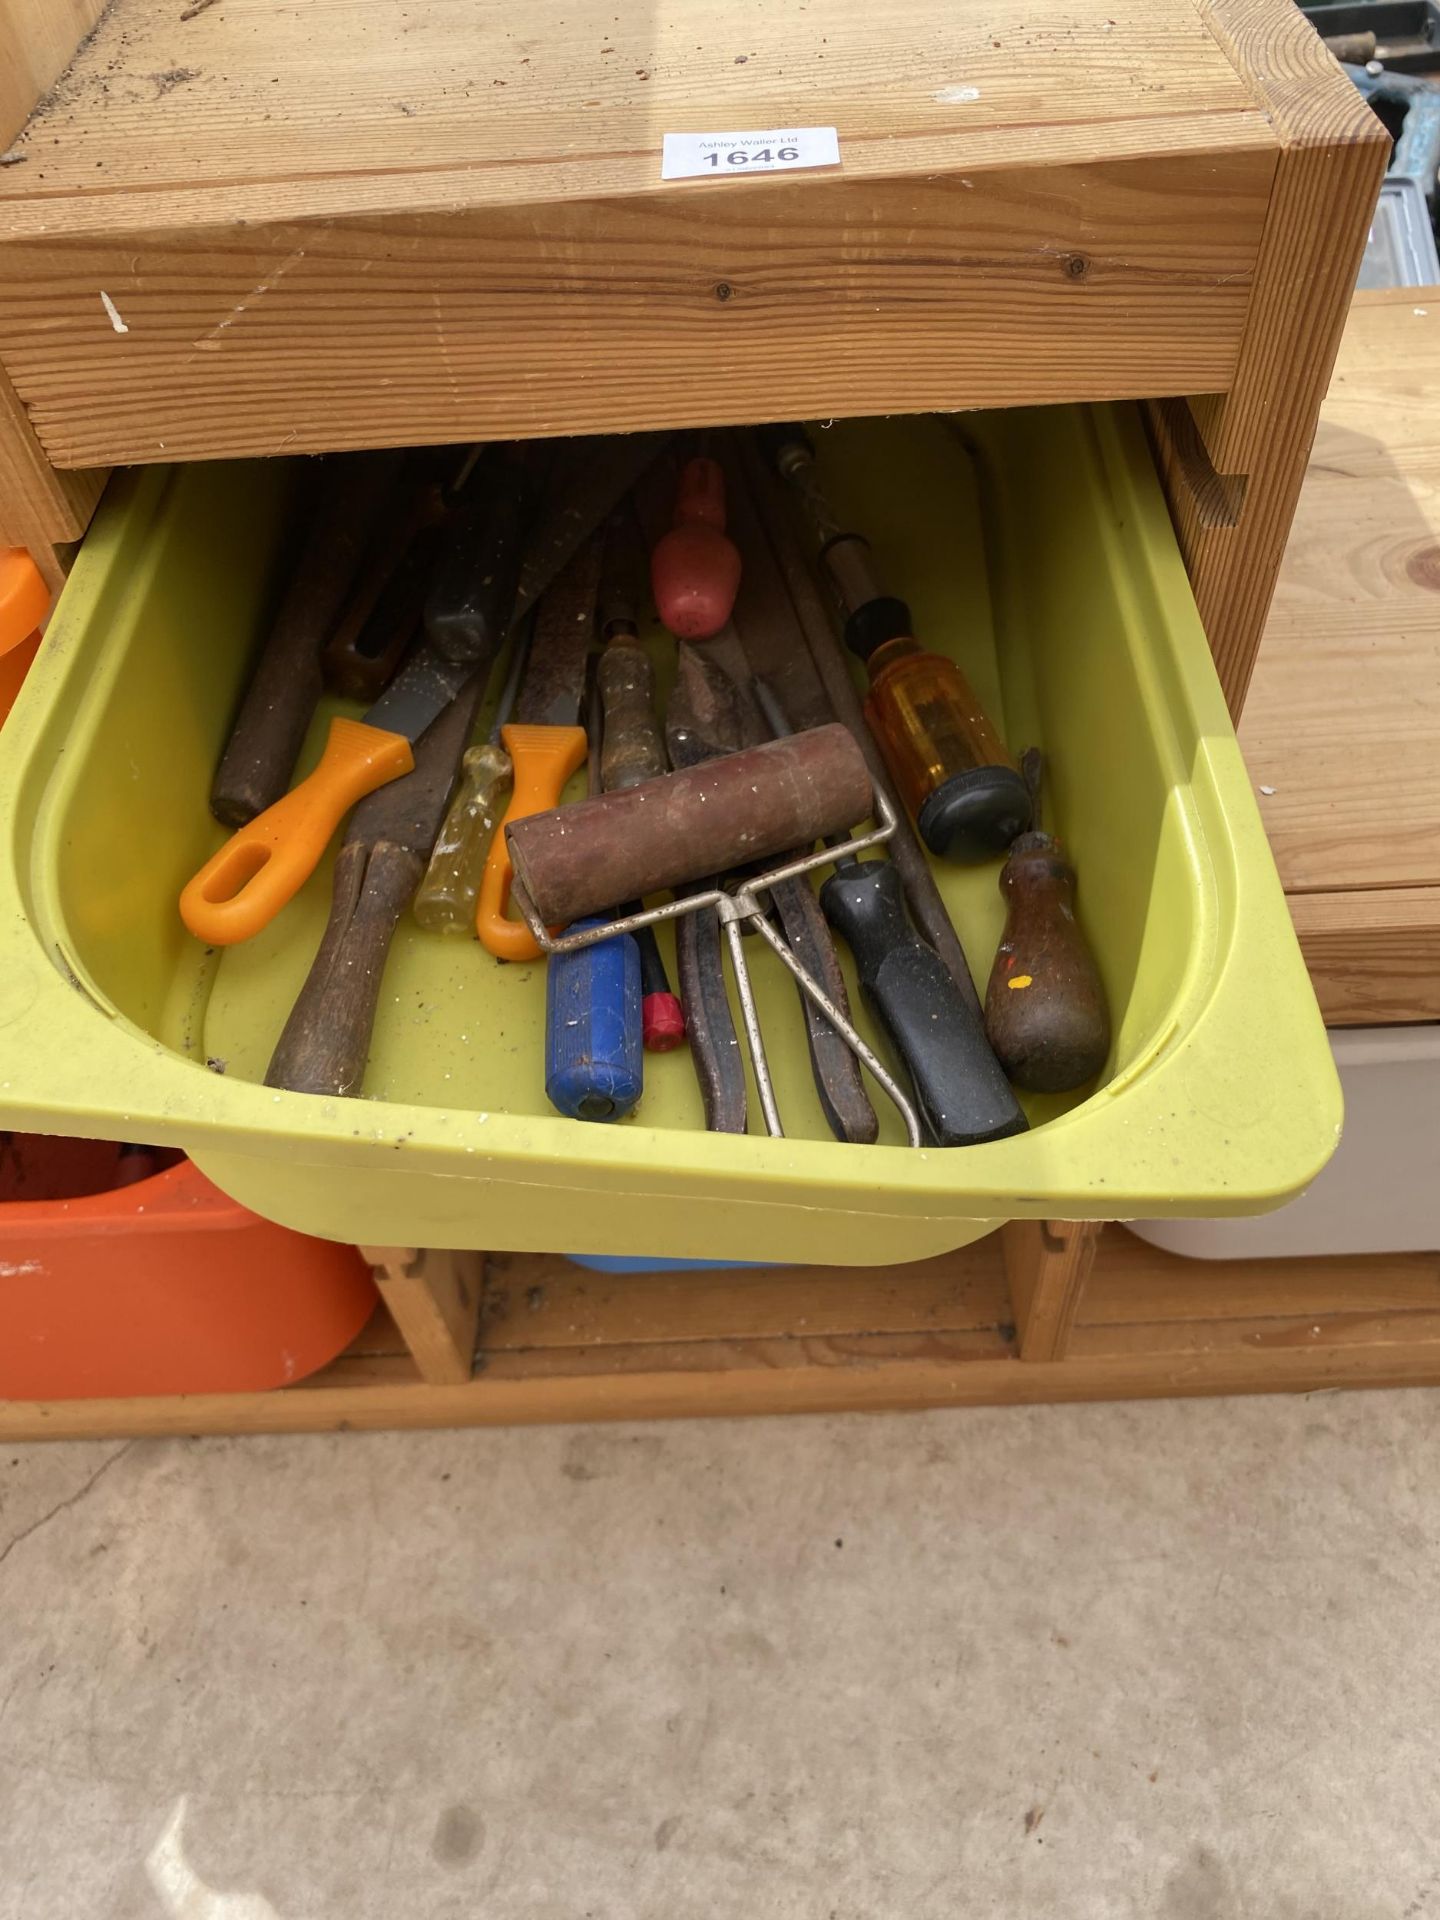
[985,749,1110,1092]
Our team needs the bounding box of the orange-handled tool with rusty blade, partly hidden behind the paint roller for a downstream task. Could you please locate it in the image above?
[474,538,601,960]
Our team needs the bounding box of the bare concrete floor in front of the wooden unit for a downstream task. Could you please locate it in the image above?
[0,1392,1440,1920]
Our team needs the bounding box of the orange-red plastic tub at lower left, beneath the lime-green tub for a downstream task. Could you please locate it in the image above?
[0,1135,376,1400]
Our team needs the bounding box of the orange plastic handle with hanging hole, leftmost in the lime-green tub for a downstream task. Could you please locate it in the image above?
[180,720,415,947]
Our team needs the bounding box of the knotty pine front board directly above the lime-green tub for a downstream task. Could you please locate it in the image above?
[0,150,1273,467]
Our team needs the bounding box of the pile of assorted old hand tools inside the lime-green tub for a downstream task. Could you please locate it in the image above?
[180,410,1110,1121]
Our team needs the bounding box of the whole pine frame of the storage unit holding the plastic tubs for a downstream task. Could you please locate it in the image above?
[0,0,1440,1436]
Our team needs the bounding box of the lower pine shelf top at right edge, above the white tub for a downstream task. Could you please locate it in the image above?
[1240,288,1440,1025]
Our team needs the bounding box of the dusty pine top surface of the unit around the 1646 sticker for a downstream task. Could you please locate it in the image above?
[0,0,1258,218]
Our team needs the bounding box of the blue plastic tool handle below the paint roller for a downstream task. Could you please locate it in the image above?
[545,920,645,1119]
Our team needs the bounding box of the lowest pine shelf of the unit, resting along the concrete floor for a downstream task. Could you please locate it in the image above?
[0,1227,1440,1440]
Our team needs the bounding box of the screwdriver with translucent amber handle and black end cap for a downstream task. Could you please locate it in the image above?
[760,426,1031,862]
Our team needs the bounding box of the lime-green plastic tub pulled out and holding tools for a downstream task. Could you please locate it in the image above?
[0,409,1340,1263]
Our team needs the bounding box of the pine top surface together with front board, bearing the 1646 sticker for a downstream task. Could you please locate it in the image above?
[0,0,1277,467]
